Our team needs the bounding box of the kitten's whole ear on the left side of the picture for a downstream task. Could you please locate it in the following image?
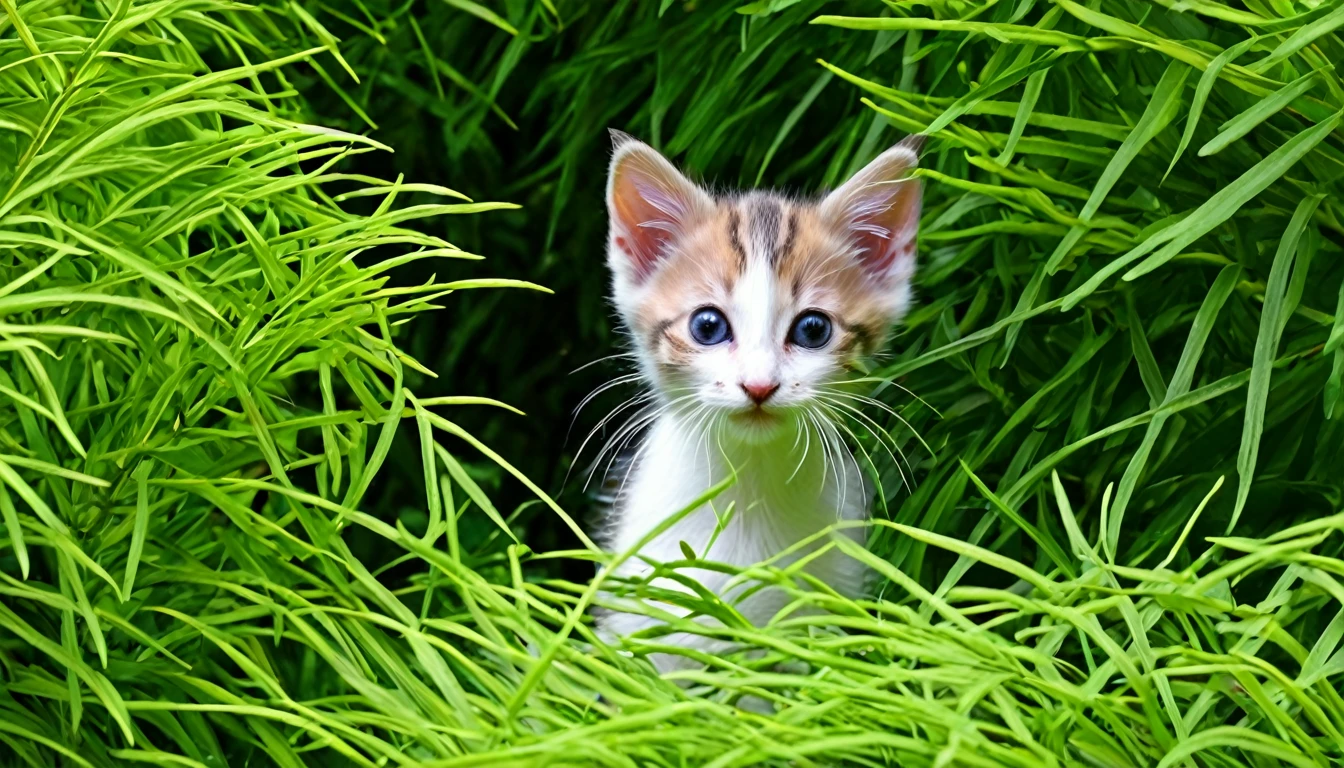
[606,130,714,284]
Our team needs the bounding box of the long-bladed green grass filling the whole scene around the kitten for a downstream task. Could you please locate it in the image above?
[0,0,1344,768]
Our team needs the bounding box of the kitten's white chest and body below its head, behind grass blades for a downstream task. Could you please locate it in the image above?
[602,416,870,668]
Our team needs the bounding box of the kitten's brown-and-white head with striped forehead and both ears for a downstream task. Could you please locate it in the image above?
[606,132,919,440]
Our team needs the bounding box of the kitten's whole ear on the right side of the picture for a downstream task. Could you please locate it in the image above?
[821,135,923,280]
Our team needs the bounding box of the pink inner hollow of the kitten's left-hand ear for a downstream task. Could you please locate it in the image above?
[610,153,689,278]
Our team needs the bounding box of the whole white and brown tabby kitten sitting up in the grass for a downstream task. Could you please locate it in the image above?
[598,130,921,671]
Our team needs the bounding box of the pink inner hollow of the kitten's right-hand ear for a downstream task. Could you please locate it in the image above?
[845,179,919,277]
